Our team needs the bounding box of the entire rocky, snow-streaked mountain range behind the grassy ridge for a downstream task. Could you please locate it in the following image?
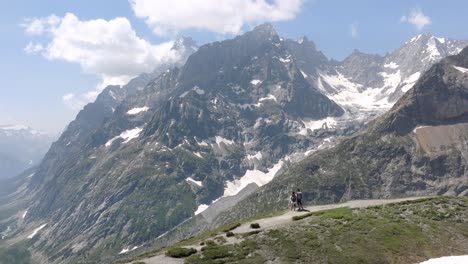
[0,24,468,263]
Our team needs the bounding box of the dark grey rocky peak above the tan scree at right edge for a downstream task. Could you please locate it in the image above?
[376,48,468,135]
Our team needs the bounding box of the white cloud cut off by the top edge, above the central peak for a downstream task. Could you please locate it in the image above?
[129,0,304,35]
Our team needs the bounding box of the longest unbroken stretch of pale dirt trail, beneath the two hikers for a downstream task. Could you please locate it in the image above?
[233,197,427,233]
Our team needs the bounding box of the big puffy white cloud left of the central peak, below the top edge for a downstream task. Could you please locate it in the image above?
[22,13,180,109]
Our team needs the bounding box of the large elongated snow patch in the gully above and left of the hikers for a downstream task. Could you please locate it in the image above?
[223,160,284,197]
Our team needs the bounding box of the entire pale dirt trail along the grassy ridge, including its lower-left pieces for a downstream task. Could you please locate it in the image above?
[134,197,427,264]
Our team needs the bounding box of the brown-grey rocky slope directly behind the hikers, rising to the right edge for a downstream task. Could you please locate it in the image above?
[216,48,468,223]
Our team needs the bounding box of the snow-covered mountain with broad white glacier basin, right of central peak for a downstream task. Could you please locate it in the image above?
[303,34,468,112]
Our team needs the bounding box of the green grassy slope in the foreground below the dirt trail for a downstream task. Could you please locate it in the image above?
[119,197,468,263]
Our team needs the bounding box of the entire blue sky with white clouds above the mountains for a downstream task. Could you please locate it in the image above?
[0,0,468,133]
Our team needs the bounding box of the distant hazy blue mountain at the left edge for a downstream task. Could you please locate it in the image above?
[0,125,55,178]
